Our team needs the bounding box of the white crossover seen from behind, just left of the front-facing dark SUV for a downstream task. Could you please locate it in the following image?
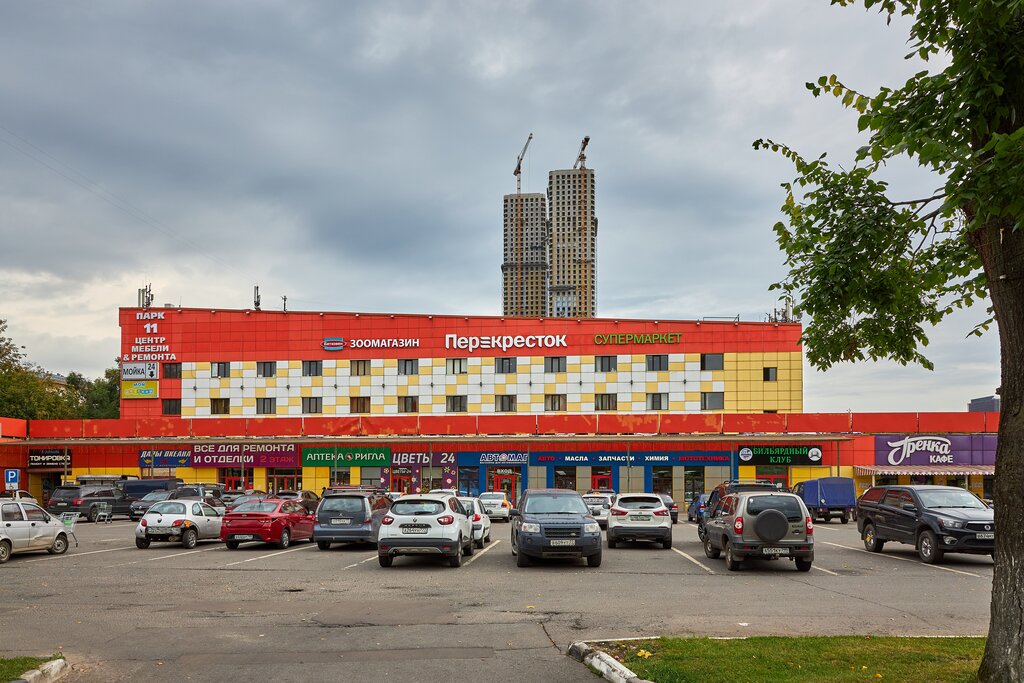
[377,494,473,567]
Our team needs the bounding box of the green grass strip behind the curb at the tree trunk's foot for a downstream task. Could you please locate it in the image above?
[594,636,985,683]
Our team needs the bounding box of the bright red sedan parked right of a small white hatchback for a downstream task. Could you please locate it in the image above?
[220,498,314,550]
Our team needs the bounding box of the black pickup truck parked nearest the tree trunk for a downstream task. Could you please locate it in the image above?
[857,486,995,564]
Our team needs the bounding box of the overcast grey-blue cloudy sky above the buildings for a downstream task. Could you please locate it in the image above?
[0,0,998,412]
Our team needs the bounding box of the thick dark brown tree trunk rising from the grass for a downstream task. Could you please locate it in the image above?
[971,220,1024,683]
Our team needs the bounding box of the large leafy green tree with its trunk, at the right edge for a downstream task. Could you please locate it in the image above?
[754,0,1024,683]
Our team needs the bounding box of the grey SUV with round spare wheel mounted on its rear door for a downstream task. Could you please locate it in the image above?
[703,492,814,571]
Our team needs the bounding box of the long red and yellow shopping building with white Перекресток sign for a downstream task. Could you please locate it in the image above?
[0,307,998,500]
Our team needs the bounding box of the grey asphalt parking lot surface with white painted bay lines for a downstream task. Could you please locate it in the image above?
[0,518,992,682]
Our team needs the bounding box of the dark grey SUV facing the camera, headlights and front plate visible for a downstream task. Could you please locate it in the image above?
[510,488,601,567]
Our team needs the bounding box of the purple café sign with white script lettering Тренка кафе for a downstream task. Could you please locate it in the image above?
[874,434,996,465]
